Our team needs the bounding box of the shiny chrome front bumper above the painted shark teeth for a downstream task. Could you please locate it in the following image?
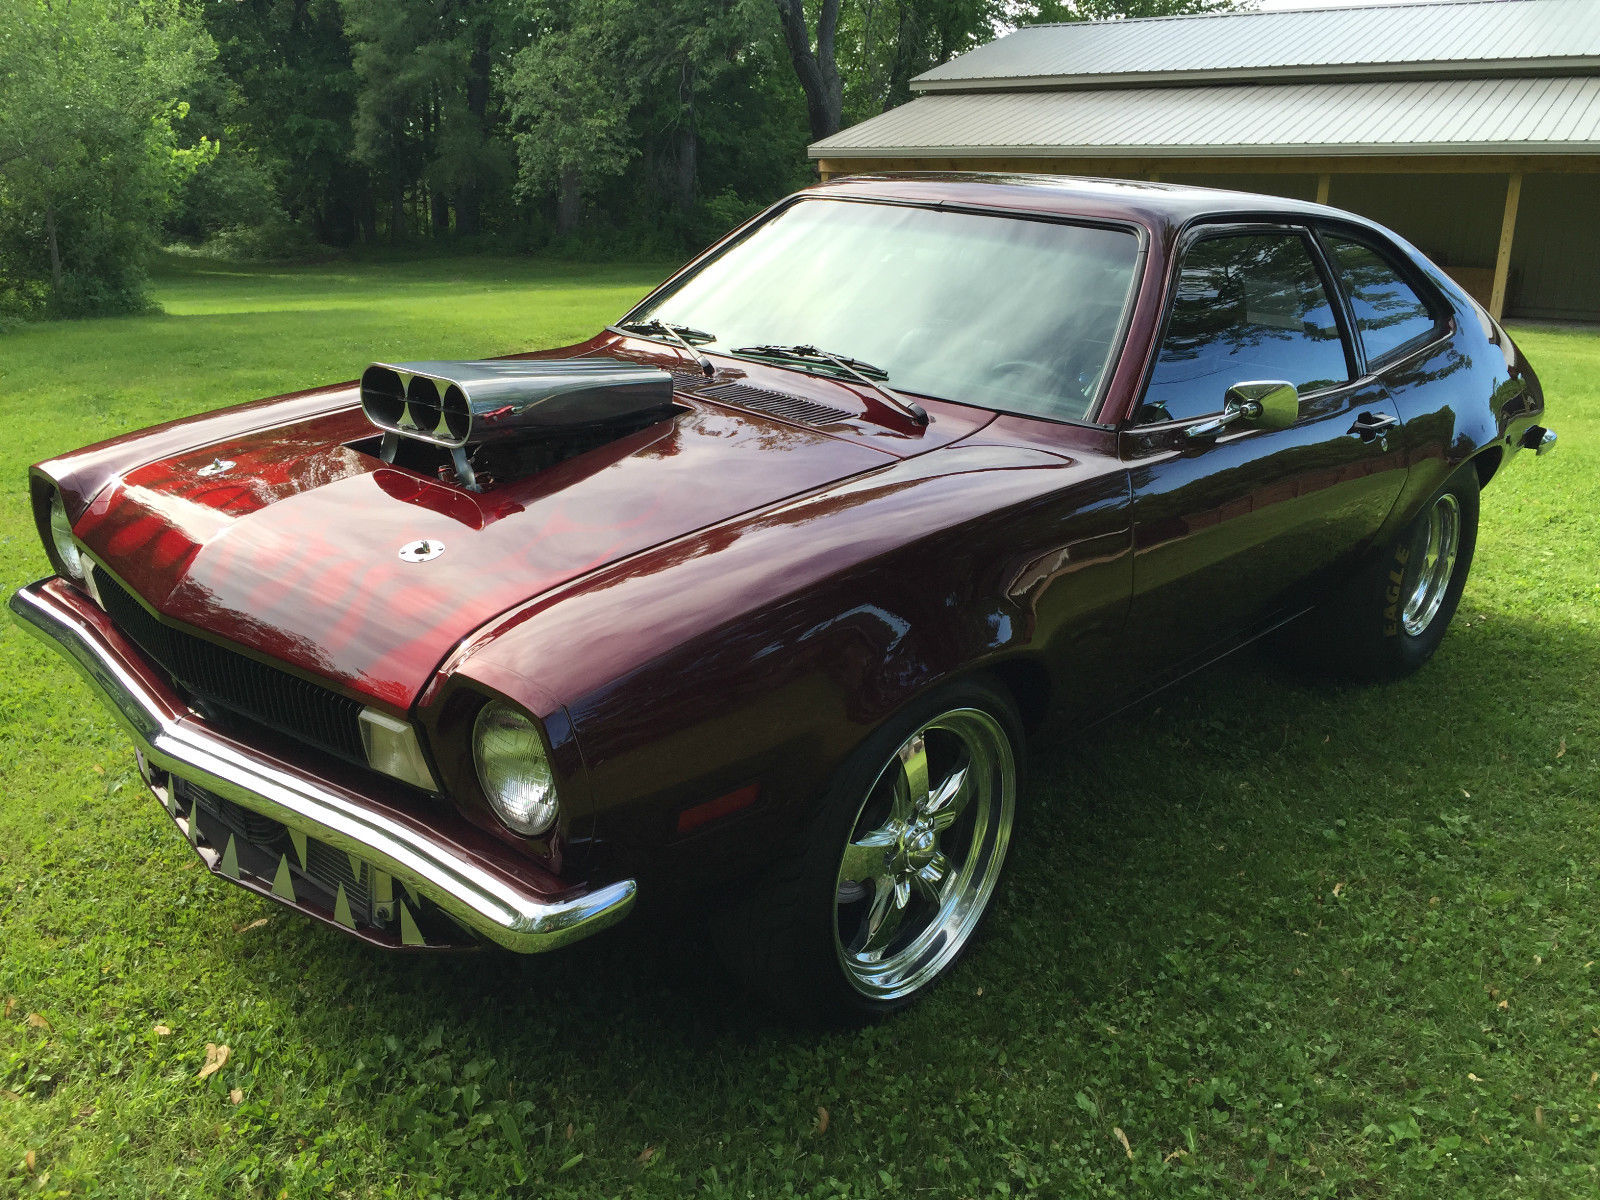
[10,579,637,954]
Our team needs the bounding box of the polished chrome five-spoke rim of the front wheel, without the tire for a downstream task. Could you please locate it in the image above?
[834,707,1016,1002]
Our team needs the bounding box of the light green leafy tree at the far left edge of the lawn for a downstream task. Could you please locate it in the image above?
[0,0,216,315]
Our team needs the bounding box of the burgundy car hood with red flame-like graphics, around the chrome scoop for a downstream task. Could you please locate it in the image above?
[75,400,896,709]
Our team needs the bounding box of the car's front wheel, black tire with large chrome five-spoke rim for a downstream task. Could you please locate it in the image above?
[714,682,1022,1024]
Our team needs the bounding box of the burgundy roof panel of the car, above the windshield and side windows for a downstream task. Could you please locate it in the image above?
[806,171,1371,240]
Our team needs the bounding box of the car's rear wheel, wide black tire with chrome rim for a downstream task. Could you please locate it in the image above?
[1293,462,1478,680]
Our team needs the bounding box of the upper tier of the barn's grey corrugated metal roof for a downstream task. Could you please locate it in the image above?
[912,0,1600,91]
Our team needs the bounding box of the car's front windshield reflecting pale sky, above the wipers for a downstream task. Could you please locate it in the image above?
[629,200,1139,421]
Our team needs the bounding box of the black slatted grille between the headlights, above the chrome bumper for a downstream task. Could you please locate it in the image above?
[94,571,366,763]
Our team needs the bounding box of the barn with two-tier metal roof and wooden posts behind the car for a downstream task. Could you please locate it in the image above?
[811,0,1600,320]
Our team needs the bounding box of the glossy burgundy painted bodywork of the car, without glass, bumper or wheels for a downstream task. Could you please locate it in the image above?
[28,176,1542,896]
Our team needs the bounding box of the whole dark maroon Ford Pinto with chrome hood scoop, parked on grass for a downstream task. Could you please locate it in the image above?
[11,174,1554,1018]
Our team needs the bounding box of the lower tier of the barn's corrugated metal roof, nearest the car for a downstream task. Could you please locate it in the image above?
[811,75,1600,158]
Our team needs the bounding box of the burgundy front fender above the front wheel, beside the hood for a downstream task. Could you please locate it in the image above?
[454,446,1128,896]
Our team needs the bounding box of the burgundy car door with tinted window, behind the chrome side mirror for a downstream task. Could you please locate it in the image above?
[1122,224,1406,677]
